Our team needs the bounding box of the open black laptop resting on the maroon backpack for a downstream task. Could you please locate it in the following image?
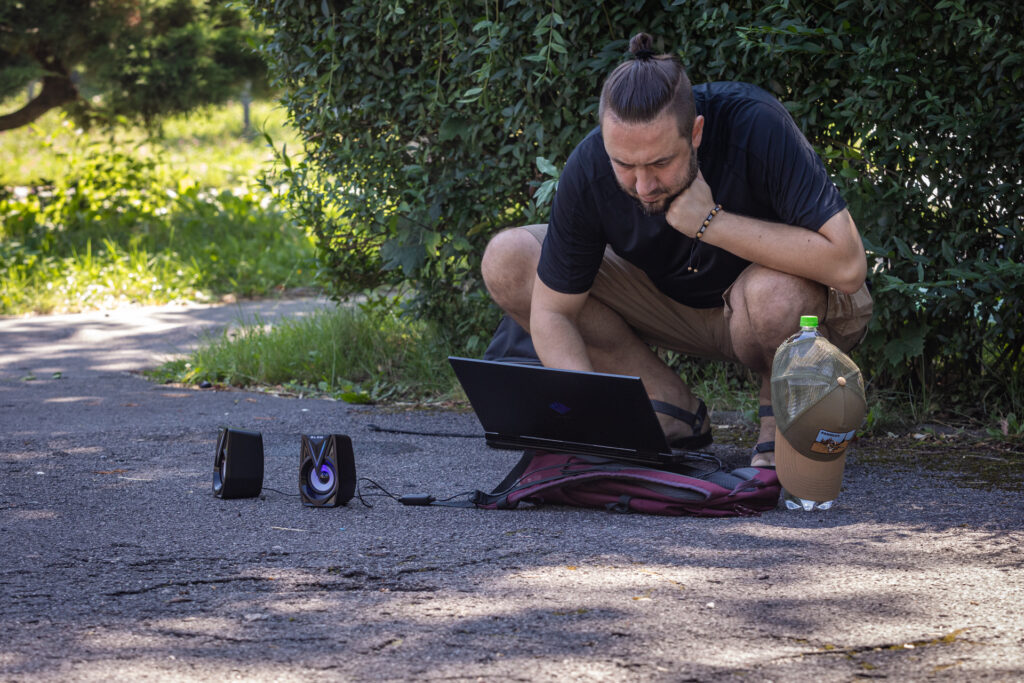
[449,356,694,467]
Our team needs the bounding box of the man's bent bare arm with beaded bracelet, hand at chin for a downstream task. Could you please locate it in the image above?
[666,174,867,294]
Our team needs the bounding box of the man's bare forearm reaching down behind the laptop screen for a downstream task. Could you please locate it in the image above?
[529,278,594,372]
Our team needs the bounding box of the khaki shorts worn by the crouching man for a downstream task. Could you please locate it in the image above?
[524,225,872,360]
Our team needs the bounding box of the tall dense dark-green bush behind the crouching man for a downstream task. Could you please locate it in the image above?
[251,0,1024,417]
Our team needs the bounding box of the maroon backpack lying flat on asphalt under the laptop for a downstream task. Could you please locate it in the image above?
[472,451,779,517]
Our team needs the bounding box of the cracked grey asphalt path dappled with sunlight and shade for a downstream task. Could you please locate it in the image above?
[0,301,1024,682]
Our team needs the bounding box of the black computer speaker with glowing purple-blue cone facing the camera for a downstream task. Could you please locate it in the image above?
[299,434,355,508]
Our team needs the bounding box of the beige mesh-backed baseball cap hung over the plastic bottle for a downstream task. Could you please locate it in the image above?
[771,327,867,503]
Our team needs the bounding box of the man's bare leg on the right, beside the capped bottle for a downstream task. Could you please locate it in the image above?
[729,265,826,465]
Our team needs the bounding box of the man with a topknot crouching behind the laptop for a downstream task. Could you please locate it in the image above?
[482,34,871,467]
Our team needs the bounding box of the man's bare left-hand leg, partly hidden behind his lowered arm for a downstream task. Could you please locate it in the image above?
[481,228,711,441]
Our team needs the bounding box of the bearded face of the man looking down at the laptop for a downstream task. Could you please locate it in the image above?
[601,113,703,215]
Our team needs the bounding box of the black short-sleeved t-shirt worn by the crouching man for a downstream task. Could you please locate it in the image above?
[538,78,846,308]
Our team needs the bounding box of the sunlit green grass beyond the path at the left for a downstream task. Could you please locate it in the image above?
[0,98,316,314]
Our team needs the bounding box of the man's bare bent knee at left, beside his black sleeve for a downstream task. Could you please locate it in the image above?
[480,227,541,312]
